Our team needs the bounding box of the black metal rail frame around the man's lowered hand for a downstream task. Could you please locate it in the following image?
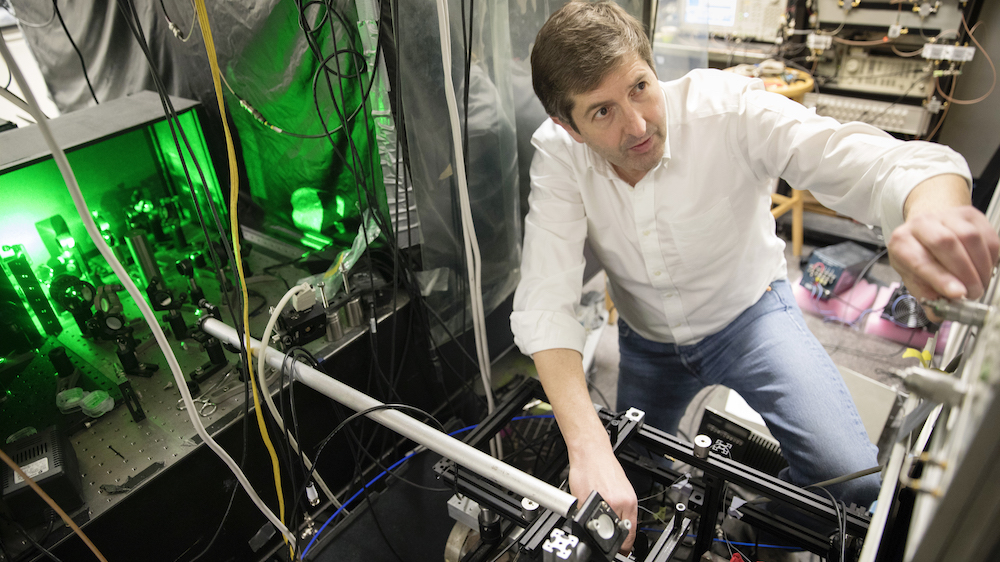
[435,380,869,562]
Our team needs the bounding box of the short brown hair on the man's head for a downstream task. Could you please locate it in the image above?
[531,1,656,132]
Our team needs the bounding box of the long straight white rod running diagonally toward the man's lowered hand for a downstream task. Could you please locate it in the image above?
[201,317,576,517]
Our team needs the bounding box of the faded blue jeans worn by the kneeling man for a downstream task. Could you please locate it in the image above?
[617,280,880,507]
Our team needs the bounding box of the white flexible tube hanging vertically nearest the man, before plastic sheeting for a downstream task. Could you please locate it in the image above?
[437,0,503,456]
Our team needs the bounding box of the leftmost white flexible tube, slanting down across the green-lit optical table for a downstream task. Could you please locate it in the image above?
[0,34,295,549]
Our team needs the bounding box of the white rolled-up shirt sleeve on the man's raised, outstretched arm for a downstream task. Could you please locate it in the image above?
[734,77,972,236]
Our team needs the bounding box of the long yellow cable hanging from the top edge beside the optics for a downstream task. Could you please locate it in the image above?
[195,0,294,544]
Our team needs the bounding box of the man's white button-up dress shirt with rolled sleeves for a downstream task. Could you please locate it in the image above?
[511,70,971,355]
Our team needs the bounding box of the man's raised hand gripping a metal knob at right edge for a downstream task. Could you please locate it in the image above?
[888,176,1000,306]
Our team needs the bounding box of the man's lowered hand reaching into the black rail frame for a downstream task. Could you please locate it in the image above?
[569,447,639,554]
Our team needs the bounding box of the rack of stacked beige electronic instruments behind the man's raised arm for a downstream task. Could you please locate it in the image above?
[802,0,986,139]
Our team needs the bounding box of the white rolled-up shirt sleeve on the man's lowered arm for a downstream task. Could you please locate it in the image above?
[510,121,587,355]
